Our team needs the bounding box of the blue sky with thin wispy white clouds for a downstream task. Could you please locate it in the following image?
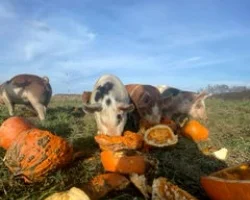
[0,0,250,93]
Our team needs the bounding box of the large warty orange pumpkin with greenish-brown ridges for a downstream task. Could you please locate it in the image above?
[4,128,73,182]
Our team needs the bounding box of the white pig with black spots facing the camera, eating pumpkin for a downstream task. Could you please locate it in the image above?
[83,74,134,136]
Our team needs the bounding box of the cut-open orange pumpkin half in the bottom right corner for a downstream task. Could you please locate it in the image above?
[201,163,250,200]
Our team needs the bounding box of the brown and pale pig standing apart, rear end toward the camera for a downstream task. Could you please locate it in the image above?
[0,74,52,121]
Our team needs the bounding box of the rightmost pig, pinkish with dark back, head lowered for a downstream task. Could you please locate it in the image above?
[158,86,211,120]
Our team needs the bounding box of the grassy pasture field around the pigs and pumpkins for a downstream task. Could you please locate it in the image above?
[0,95,250,200]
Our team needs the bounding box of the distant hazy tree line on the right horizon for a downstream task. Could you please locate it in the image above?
[199,84,250,94]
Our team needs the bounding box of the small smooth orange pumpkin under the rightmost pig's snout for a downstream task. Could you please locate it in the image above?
[181,120,209,142]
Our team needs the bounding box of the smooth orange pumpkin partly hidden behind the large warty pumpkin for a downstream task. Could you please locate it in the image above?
[0,116,34,150]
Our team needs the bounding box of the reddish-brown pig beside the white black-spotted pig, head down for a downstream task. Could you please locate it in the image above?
[125,84,170,133]
